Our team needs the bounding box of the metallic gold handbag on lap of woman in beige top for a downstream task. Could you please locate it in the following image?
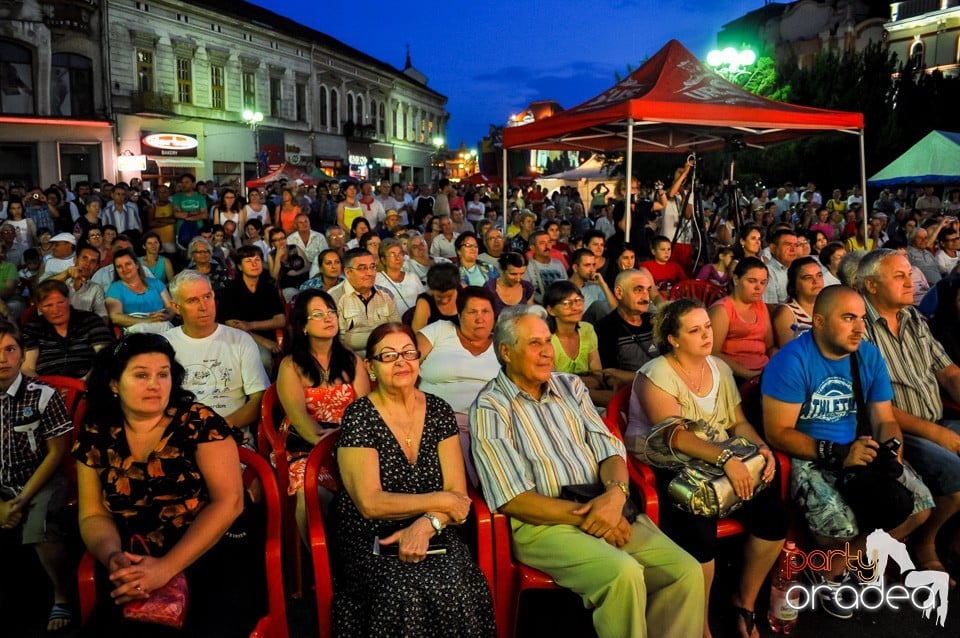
[640,417,767,518]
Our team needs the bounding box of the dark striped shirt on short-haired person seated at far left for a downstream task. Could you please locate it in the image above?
[23,309,113,379]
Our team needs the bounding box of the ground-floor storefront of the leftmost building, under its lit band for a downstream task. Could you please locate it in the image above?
[0,116,115,188]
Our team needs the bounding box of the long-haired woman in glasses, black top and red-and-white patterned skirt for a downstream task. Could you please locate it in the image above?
[277,289,370,538]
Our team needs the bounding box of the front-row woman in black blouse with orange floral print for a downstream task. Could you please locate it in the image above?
[73,334,266,637]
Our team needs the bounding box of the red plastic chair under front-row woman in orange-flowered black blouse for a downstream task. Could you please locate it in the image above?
[77,448,289,638]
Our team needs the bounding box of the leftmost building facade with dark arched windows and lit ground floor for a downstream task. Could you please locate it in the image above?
[0,0,115,188]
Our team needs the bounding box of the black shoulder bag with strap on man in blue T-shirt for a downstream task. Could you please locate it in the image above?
[837,352,913,533]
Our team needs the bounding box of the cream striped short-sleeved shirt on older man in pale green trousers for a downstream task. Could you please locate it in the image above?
[470,370,626,510]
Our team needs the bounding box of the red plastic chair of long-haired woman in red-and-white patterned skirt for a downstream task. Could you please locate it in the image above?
[257,384,303,598]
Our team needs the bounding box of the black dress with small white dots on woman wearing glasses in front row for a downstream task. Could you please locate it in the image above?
[332,394,494,637]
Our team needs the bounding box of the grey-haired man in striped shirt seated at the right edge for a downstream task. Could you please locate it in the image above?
[857,249,960,570]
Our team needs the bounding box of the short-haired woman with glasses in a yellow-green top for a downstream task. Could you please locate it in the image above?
[543,279,612,405]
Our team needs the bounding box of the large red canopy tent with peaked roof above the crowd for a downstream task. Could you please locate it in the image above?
[503,40,866,240]
